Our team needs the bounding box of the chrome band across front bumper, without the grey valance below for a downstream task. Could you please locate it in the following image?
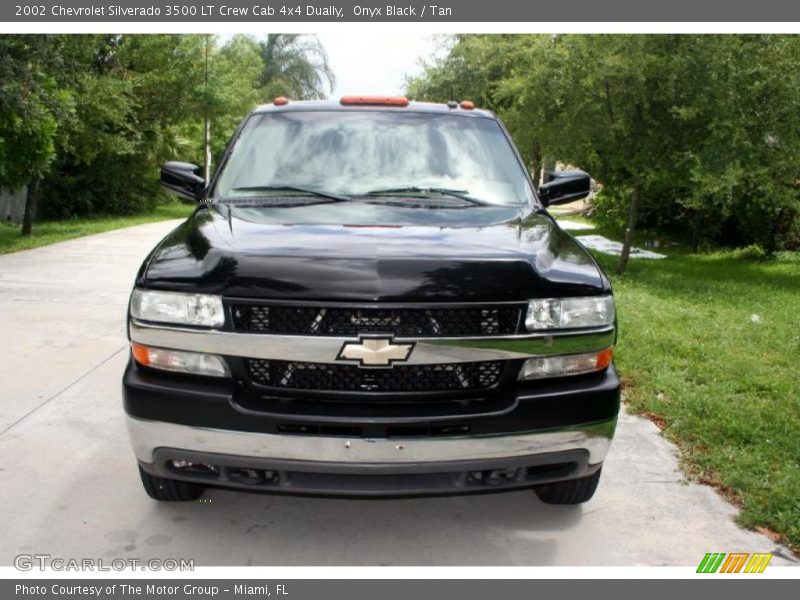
[127,417,617,464]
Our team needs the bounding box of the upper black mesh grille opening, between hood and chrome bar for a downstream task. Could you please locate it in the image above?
[233,304,520,337]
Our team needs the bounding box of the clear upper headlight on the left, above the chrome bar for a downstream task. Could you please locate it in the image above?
[131,289,225,327]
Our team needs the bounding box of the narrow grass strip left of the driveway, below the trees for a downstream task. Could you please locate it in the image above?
[0,201,195,254]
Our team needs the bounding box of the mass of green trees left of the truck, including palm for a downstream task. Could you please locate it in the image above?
[0,35,333,225]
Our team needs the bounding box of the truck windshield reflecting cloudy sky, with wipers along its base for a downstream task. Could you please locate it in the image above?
[214,111,532,205]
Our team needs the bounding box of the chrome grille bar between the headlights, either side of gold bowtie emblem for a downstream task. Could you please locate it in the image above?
[129,319,614,365]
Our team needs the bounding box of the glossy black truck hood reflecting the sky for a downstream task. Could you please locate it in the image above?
[137,202,609,302]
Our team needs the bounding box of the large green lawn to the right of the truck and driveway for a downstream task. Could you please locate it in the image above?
[596,246,800,551]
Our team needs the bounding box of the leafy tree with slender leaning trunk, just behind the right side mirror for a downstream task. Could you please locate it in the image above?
[410,36,670,272]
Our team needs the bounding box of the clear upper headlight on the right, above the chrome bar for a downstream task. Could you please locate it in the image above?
[525,296,614,331]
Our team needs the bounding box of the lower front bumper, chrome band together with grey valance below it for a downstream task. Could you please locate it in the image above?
[133,417,616,496]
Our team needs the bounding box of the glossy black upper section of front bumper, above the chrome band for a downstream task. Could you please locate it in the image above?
[122,361,620,439]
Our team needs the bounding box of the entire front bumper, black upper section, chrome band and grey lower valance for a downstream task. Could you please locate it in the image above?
[123,352,619,496]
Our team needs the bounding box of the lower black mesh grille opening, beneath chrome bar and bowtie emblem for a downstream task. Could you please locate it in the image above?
[247,359,502,392]
